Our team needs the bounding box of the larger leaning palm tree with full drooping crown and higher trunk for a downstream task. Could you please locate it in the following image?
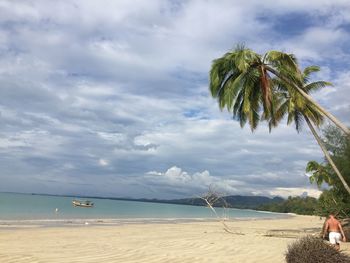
[210,46,350,135]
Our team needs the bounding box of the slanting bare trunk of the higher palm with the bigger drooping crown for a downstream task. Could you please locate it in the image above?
[265,66,350,135]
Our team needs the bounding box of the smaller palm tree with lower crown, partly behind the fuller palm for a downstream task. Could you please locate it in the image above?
[265,66,350,194]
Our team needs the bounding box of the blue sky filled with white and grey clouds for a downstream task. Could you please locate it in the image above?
[0,0,350,198]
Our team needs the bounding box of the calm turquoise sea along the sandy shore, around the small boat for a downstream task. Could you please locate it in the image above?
[0,193,286,225]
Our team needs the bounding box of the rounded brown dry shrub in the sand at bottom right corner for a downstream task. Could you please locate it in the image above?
[286,236,350,263]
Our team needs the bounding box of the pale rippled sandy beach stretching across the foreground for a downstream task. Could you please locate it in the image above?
[0,216,350,263]
